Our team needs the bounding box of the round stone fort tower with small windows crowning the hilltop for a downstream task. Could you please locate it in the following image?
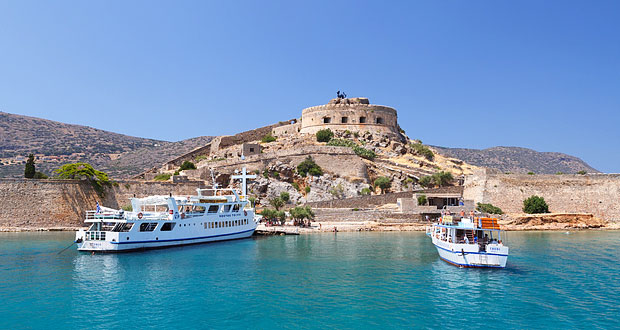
[300,97,401,137]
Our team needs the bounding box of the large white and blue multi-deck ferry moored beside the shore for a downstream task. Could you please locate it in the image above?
[76,169,257,252]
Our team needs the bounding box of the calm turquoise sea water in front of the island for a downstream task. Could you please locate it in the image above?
[0,232,620,329]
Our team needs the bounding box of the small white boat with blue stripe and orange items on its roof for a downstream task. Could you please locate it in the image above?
[426,215,508,268]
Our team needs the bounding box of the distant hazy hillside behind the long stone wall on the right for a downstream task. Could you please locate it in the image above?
[433,147,599,174]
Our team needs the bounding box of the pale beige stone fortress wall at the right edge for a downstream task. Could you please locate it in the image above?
[463,170,620,221]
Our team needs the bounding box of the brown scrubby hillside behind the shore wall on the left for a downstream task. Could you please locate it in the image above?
[0,112,211,177]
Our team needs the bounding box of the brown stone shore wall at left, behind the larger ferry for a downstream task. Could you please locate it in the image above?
[0,179,208,228]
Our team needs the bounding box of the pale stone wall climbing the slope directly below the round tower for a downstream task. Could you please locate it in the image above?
[185,146,368,181]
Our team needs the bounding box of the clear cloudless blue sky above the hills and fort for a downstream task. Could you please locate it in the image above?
[0,0,620,172]
